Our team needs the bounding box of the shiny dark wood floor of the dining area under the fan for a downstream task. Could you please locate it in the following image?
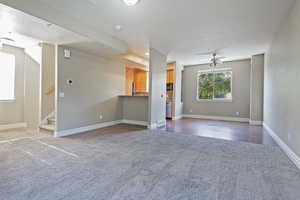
[160,119,277,146]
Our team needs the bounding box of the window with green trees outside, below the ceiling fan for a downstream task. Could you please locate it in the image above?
[197,70,232,101]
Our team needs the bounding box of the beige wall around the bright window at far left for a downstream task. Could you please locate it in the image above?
[0,45,40,128]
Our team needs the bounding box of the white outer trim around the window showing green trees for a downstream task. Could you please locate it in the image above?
[196,68,233,103]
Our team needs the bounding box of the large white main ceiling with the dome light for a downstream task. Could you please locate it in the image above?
[0,0,295,65]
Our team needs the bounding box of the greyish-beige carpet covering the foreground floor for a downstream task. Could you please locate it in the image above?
[0,127,300,200]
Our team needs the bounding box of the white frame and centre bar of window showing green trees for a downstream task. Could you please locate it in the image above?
[196,68,233,103]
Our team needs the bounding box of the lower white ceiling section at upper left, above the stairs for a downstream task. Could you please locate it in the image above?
[0,4,119,57]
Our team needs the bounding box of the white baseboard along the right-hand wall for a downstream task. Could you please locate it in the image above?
[263,123,300,169]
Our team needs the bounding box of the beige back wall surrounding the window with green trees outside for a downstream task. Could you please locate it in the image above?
[182,59,251,118]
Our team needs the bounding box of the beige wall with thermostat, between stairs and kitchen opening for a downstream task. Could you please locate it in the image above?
[57,46,125,131]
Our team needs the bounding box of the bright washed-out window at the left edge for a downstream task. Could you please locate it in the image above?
[0,52,15,101]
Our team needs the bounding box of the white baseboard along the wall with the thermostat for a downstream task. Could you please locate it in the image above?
[54,120,122,137]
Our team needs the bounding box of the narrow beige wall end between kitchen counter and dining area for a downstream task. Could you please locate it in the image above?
[148,49,167,126]
